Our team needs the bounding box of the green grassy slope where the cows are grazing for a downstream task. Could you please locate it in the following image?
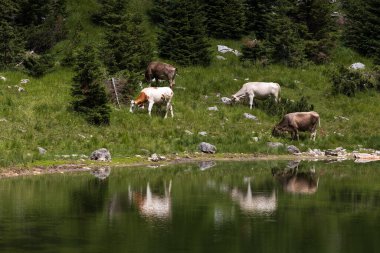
[0,0,380,166]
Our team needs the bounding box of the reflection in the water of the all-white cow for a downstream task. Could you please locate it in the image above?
[231,182,277,214]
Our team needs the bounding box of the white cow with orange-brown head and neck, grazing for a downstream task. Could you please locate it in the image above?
[129,87,174,118]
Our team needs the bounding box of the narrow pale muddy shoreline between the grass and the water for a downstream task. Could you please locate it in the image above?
[0,153,354,179]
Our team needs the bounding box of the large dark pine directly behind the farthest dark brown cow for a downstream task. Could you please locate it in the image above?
[158,0,211,65]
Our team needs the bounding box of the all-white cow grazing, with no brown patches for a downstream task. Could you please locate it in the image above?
[232,82,281,109]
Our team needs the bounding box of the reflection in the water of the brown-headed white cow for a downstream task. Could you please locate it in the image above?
[133,180,172,219]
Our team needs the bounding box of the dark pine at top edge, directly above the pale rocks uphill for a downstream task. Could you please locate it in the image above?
[204,0,245,39]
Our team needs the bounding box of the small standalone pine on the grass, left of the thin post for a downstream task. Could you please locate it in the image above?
[71,45,111,125]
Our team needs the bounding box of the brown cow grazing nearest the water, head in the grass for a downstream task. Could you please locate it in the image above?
[272,112,320,141]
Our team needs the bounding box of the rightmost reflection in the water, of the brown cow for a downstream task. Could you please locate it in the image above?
[272,161,319,194]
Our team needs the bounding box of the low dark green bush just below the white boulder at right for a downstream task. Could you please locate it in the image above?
[331,66,376,97]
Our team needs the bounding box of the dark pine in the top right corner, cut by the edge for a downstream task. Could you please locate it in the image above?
[343,0,380,64]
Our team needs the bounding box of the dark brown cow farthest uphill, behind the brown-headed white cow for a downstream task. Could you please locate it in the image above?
[145,61,177,88]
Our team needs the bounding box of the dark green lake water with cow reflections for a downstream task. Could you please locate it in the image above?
[0,161,380,253]
